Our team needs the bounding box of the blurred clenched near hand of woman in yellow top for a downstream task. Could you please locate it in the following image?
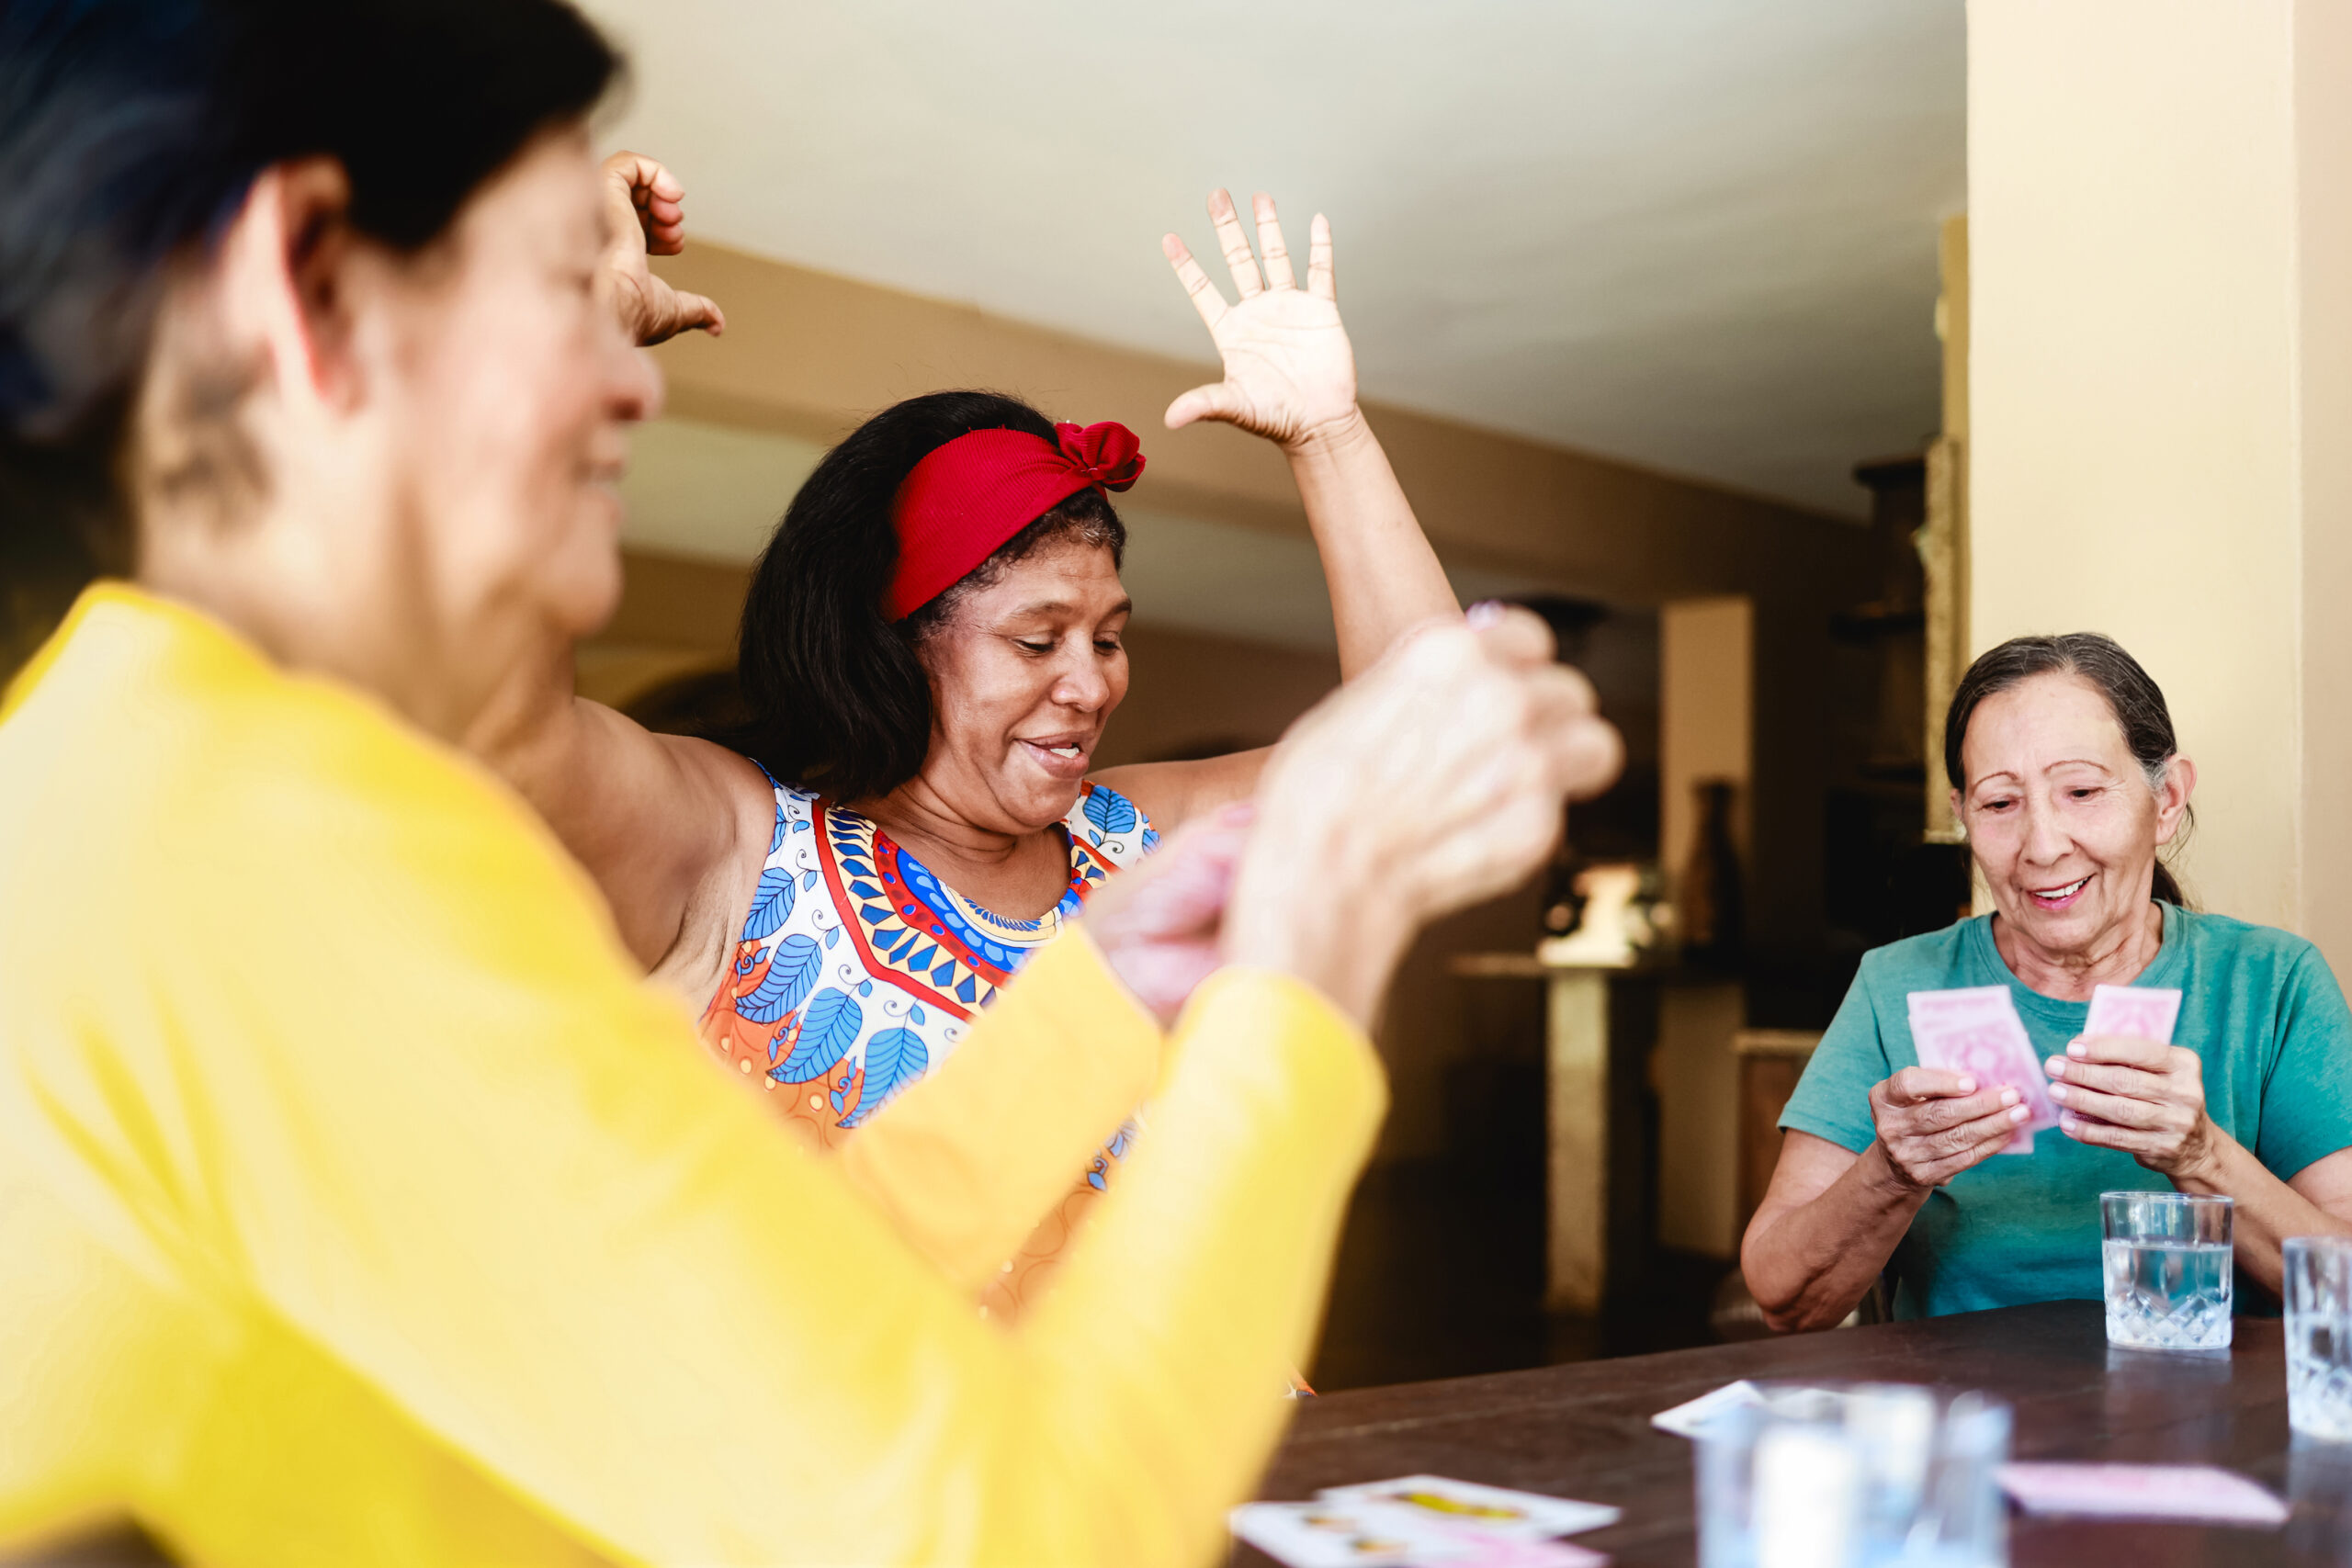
[1226,606,1623,1021]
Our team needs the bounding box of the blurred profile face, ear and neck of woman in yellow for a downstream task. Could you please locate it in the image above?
[139,127,661,739]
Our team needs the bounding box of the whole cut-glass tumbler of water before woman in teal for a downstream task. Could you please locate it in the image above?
[2098,1192,2234,1349]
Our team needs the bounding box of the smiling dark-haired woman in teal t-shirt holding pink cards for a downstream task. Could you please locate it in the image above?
[1740,632,2352,1328]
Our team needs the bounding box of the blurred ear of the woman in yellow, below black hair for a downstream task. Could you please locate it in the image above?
[219,157,357,407]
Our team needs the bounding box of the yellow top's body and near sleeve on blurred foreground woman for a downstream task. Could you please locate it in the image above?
[0,590,1383,1565]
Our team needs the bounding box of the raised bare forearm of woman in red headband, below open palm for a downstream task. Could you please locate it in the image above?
[1284,409,1461,677]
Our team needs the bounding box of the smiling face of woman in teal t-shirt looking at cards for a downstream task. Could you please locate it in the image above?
[1952,674,2197,959]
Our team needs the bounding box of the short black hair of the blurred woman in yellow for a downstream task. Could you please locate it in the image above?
[0,0,621,653]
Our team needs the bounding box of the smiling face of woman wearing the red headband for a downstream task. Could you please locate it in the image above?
[917,541,1131,832]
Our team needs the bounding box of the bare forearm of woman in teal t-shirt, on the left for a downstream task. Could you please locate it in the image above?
[1740,1143,1928,1333]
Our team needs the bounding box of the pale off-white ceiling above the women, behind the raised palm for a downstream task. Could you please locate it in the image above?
[588,0,1966,514]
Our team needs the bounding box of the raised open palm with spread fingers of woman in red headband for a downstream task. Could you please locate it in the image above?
[1159,190,1355,446]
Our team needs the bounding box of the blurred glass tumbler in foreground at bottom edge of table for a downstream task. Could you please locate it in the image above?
[1696,1382,2008,1568]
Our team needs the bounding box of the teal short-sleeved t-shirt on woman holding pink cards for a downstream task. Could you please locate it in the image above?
[1781,905,2352,1316]
